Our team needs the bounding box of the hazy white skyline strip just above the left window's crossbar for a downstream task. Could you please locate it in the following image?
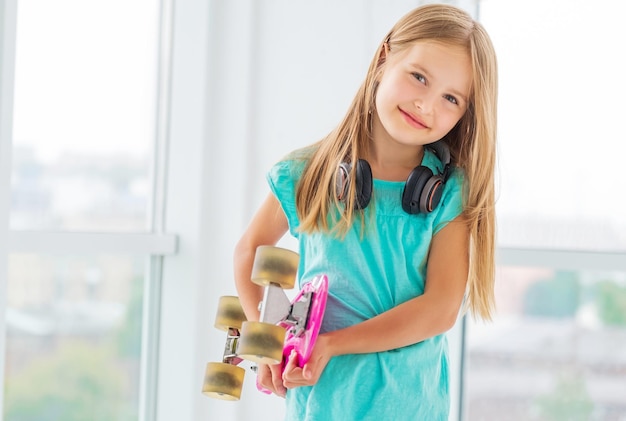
[10,144,152,232]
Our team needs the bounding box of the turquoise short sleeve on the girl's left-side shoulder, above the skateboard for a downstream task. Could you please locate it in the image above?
[267,160,304,238]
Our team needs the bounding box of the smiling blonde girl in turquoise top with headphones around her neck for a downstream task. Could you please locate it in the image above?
[234,5,497,421]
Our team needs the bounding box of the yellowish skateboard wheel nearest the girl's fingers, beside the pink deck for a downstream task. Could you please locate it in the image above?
[237,322,286,365]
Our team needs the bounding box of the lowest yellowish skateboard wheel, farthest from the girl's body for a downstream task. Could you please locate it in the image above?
[202,363,246,401]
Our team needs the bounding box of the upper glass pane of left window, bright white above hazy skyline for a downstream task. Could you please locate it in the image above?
[10,0,159,231]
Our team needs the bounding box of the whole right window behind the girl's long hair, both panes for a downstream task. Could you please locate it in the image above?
[465,0,626,420]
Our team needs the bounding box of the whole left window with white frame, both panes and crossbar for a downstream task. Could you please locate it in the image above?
[0,0,171,421]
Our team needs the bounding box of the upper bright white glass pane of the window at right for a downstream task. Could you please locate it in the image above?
[480,0,626,251]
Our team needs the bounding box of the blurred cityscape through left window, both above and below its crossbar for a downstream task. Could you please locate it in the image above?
[3,146,150,421]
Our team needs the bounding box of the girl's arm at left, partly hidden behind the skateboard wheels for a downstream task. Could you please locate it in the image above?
[234,193,289,321]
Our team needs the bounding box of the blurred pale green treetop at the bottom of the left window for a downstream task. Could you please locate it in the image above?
[4,341,136,421]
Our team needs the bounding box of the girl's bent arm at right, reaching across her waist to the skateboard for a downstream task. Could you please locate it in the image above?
[283,216,469,388]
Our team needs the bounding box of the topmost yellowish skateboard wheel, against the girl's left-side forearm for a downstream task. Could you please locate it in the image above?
[251,246,300,289]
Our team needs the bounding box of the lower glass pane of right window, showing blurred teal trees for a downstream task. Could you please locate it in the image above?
[466,267,626,421]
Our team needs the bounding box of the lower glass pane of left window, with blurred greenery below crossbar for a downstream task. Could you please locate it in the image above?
[3,254,145,421]
